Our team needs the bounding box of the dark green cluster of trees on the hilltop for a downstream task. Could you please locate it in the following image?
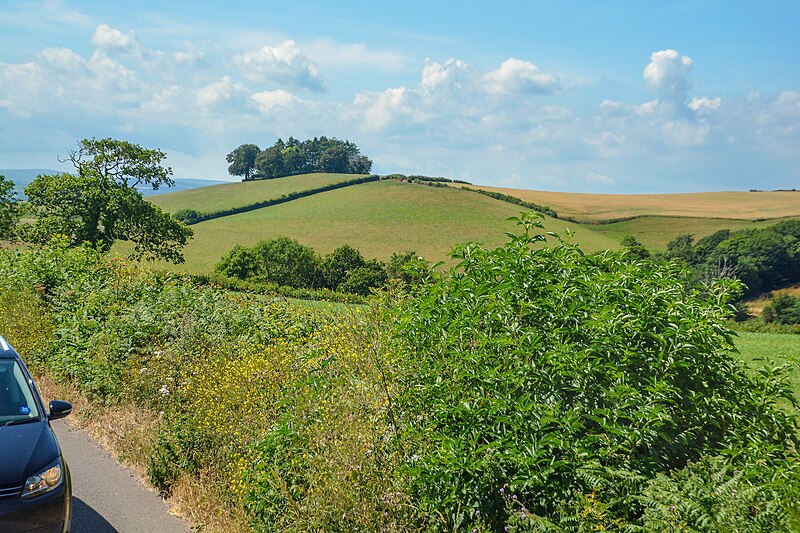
[225,136,372,181]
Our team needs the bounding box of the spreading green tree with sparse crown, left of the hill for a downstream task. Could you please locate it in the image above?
[25,139,192,263]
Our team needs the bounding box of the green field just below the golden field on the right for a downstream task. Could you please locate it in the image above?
[591,216,792,252]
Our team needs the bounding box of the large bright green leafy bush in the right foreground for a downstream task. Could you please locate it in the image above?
[395,212,797,531]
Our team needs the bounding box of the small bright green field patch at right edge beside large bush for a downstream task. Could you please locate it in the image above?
[735,332,800,398]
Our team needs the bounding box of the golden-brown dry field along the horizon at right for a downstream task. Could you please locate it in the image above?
[460,186,800,222]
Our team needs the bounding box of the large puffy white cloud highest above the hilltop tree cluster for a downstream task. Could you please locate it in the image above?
[233,40,325,91]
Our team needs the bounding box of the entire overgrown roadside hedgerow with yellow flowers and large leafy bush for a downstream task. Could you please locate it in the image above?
[0,216,800,531]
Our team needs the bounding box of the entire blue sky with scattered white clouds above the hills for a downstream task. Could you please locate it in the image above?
[0,0,800,192]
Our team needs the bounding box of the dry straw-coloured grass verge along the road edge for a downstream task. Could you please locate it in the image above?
[35,373,247,533]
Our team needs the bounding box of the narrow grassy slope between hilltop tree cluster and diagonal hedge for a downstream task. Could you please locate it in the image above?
[148,170,363,213]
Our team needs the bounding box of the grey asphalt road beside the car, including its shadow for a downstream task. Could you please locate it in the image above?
[52,420,191,533]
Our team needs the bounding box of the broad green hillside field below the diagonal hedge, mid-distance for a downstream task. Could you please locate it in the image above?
[162,181,619,272]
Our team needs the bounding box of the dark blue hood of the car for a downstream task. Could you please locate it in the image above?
[0,421,59,488]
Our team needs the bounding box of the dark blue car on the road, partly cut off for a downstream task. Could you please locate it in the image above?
[0,337,72,533]
